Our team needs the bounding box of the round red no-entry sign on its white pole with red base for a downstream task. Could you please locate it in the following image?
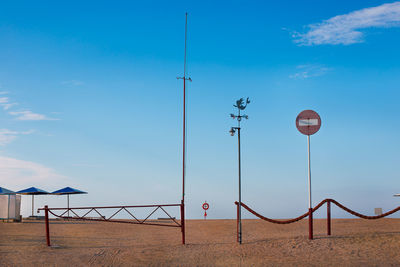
[296,110,321,242]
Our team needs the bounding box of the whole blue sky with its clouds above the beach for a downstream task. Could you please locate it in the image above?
[0,1,400,218]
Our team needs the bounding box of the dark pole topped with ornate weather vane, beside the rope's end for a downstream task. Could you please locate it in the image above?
[229,98,250,244]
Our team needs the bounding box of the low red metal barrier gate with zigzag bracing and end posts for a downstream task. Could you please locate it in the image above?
[38,204,185,246]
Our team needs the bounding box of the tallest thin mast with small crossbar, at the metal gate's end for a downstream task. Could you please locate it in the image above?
[177,13,192,244]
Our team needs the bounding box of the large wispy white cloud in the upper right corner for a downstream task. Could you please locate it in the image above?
[292,2,400,45]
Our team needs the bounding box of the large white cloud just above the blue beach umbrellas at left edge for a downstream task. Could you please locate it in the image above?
[0,156,67,190]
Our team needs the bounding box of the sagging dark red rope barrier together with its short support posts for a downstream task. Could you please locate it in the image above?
[235,198,400,244]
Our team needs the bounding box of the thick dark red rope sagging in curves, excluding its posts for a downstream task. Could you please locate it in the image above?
[235,198,400,224]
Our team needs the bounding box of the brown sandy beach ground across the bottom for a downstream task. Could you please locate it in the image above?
[0,219,400,266]
